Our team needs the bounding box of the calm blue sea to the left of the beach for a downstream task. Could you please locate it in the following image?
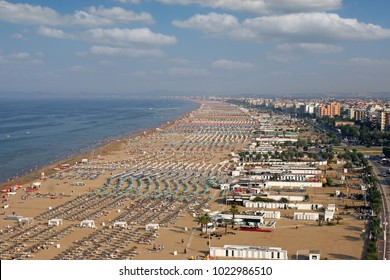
[0,98,196,183]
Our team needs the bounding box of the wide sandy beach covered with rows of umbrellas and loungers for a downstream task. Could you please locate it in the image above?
[0,100,365,260]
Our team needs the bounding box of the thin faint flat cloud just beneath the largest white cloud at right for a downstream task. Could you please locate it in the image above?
[276,43,343,53]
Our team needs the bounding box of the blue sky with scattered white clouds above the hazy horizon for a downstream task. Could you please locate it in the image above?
[0,0,390,97]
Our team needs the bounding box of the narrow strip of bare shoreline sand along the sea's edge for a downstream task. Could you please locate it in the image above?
[0,98,200,190]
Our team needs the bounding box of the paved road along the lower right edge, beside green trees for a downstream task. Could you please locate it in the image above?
[371,161,390,260]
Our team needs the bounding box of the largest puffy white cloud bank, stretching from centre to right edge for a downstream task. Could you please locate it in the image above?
[173,13,390,43]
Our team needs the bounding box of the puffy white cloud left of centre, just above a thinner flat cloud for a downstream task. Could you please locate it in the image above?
[86,28,177,46]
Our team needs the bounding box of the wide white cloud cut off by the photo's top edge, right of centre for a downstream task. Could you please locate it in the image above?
[159,0,341,14]
